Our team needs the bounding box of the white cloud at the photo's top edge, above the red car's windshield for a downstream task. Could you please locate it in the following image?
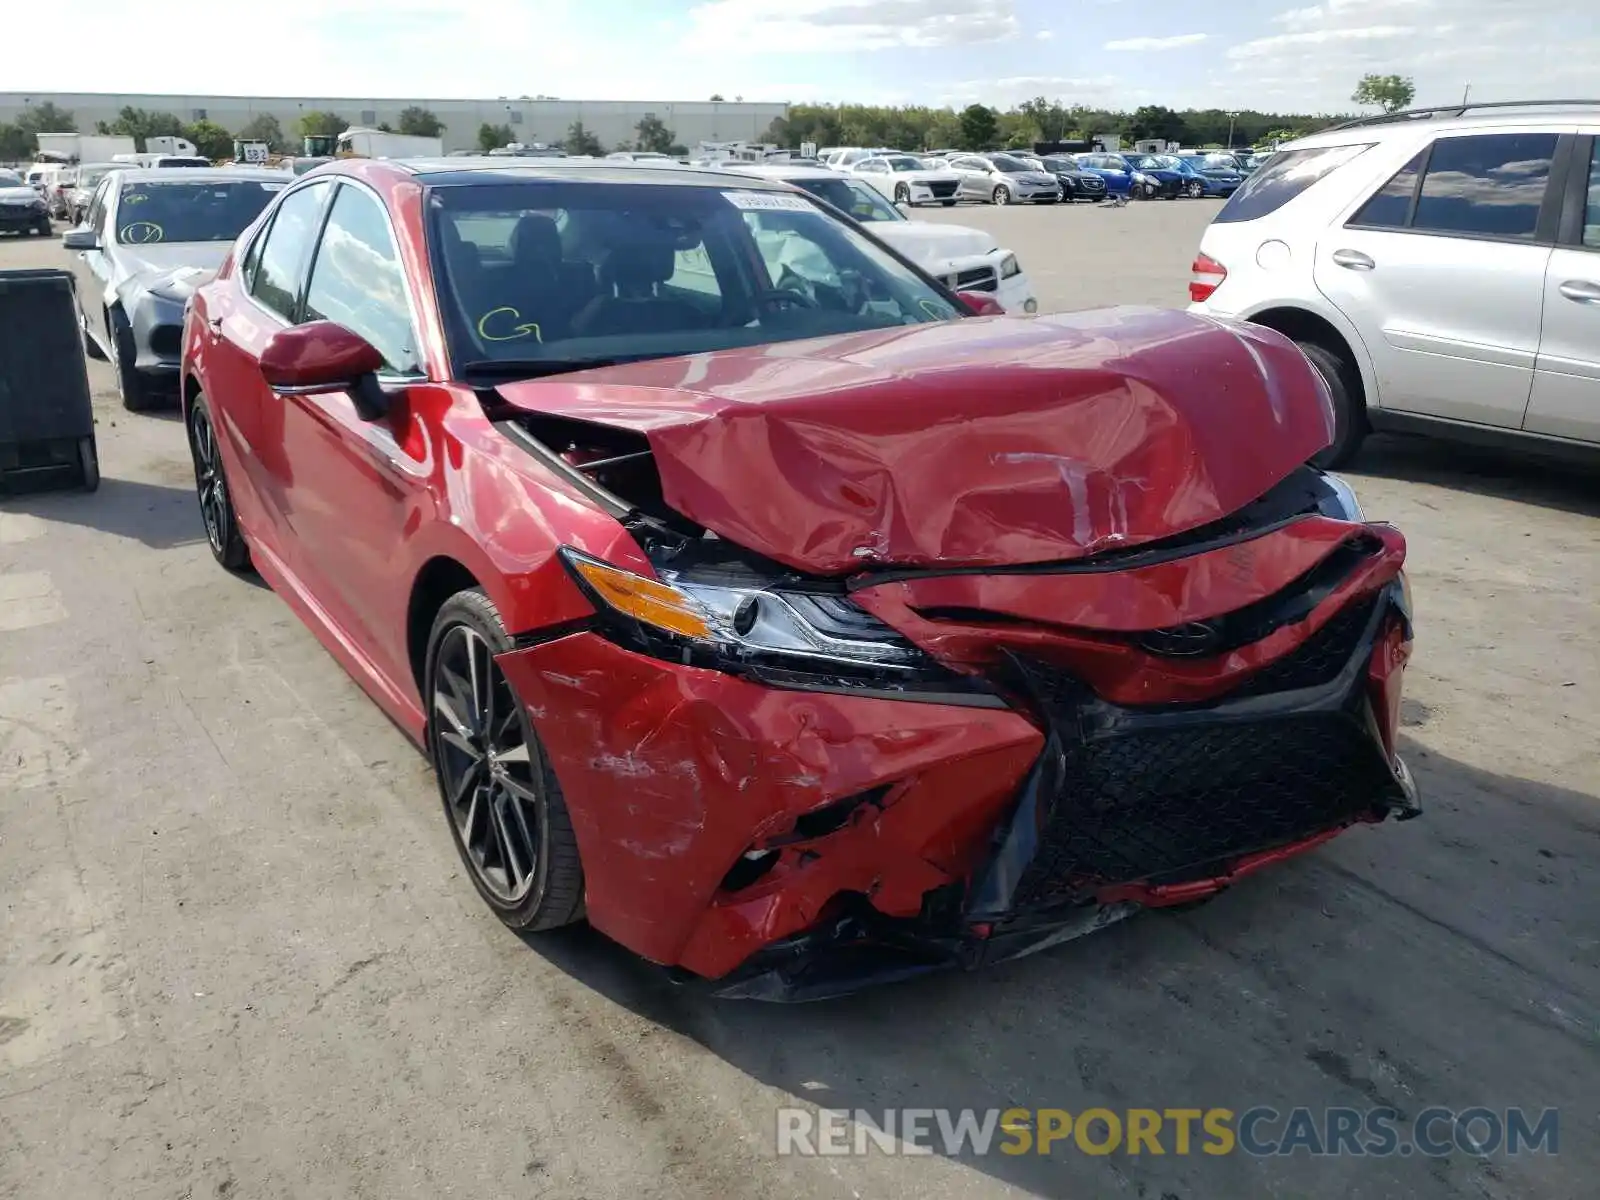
[686,0,1021,54]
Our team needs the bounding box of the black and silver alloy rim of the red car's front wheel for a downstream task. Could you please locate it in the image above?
[429,624,544,906]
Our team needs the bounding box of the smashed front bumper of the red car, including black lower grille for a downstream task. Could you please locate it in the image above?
[499,578,1419,1000]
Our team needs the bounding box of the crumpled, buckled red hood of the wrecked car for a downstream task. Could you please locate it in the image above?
[498,307,1333,574]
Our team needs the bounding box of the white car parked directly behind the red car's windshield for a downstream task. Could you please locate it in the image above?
[725,163,1038,314]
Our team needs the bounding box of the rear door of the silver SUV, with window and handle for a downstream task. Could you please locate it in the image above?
[1314,131,1560,429]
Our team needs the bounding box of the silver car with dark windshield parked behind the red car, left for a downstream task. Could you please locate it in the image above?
[61,166,294,413]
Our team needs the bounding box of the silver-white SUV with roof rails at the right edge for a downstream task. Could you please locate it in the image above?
[1189,101,1600,466]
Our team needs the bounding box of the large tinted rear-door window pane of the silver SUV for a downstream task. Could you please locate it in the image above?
[1411,133,1557,238]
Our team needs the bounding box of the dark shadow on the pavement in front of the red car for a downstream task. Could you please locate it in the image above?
[530,742,1600,1200]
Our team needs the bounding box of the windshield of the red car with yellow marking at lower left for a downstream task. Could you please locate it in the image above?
[429,181,963,374]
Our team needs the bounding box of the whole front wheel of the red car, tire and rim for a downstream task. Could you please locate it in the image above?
[422,587,584,931]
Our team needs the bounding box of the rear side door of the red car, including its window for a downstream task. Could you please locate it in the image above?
[203,179,333,576]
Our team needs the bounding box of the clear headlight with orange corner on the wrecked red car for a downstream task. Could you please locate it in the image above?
[562,547,1003,707]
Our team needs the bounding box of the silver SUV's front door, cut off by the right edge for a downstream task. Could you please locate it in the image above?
[1523,130,1600,442]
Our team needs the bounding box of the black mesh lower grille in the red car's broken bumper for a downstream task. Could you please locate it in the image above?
[1014,714,1400,909]
